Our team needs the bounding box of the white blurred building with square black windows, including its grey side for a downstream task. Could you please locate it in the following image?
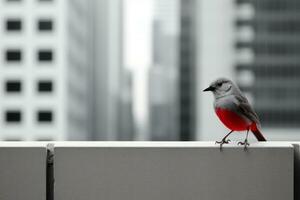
[0,0,93,140]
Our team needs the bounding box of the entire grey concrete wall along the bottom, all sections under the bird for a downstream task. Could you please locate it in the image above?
[0,142,300,200]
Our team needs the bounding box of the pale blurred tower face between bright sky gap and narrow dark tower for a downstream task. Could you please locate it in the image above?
[148,0,180,140]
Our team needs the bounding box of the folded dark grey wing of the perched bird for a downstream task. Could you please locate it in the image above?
[235,95,259,124]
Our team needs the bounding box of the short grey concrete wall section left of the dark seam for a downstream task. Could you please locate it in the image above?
[0,142,47,200]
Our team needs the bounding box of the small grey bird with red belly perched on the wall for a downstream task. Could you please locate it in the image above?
[203,78,266,148]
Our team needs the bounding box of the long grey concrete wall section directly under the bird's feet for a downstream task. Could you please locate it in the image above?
[54,142,294,200]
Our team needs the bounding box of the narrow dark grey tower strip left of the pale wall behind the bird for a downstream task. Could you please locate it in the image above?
[178,0,198,140]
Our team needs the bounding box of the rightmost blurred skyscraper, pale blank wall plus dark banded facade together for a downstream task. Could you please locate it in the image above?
[197,0,300,140]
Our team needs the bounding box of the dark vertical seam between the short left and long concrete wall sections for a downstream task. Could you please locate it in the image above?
[46,144,54,200]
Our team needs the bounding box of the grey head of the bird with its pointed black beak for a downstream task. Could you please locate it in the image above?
[203,78,241,98]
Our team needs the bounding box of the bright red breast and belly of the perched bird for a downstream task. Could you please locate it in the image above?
[215,108,256,131]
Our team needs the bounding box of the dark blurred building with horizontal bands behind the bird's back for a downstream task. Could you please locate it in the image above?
[236,0,300,139]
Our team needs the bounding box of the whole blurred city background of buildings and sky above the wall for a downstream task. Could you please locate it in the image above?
[0,0,300,141]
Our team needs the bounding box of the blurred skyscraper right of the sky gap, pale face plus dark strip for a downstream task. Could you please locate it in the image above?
[149,0,196,140]
